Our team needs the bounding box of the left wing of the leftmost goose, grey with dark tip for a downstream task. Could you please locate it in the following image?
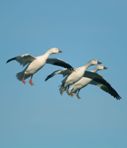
[6,54,36,66]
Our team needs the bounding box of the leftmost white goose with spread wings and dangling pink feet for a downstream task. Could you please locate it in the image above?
[6,48,72,85]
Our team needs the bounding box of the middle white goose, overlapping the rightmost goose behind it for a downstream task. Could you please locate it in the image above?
[45,59,101,94]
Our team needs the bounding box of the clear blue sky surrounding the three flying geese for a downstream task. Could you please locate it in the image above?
[0,0,127,148]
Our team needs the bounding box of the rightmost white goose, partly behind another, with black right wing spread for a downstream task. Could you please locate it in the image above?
[69,65,121,100]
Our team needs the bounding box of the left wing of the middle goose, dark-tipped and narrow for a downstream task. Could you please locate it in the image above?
[45,69,72,81]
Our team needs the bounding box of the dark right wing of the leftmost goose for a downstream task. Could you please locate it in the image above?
[46,58,73,69]
